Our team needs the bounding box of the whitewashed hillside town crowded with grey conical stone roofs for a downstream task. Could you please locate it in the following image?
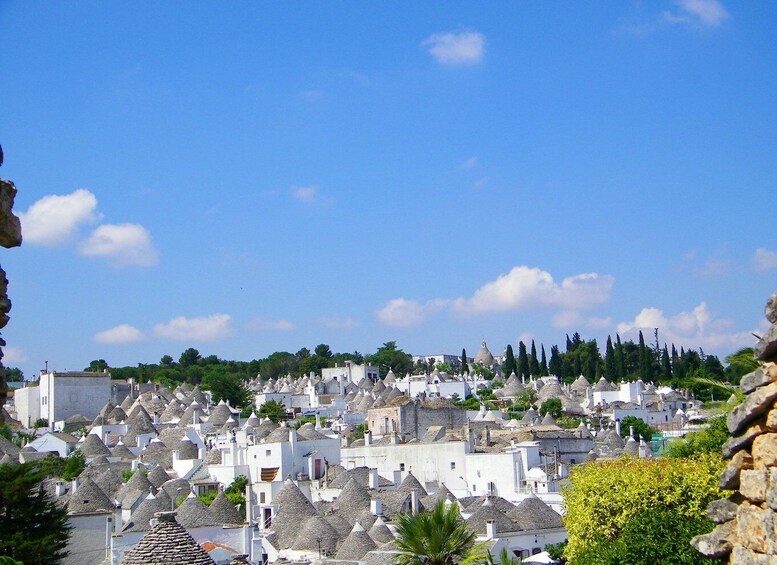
[0,334,704,565]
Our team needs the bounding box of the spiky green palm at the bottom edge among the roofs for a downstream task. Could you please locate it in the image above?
[394,501,476,565]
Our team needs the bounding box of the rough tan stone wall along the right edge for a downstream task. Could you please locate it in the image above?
[691,293,777,565]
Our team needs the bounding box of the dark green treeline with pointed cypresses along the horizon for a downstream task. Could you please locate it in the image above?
[6,330,754,403]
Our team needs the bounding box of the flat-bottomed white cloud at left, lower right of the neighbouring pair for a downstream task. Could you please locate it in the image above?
[80,224,159,267]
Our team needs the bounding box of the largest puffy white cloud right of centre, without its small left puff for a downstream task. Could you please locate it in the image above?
[453,265,614,314]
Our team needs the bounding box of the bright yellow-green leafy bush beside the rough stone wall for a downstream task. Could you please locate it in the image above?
[563,453,728,565]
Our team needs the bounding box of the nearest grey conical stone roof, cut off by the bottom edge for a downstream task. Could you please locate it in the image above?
[121,512,215,565]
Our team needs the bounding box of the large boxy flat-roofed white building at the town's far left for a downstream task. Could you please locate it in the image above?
[38,371,111,426]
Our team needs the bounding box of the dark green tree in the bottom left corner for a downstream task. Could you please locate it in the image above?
[0,458,70,565]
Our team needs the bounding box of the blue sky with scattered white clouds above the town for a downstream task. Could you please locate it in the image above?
[0,0,777,376]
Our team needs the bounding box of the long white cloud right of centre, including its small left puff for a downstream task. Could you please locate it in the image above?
[377,265,614,327]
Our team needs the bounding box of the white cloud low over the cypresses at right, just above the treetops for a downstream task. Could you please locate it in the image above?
[617,302,754,351]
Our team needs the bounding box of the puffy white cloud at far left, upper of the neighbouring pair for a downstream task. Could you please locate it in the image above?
[19,188,101,245]
